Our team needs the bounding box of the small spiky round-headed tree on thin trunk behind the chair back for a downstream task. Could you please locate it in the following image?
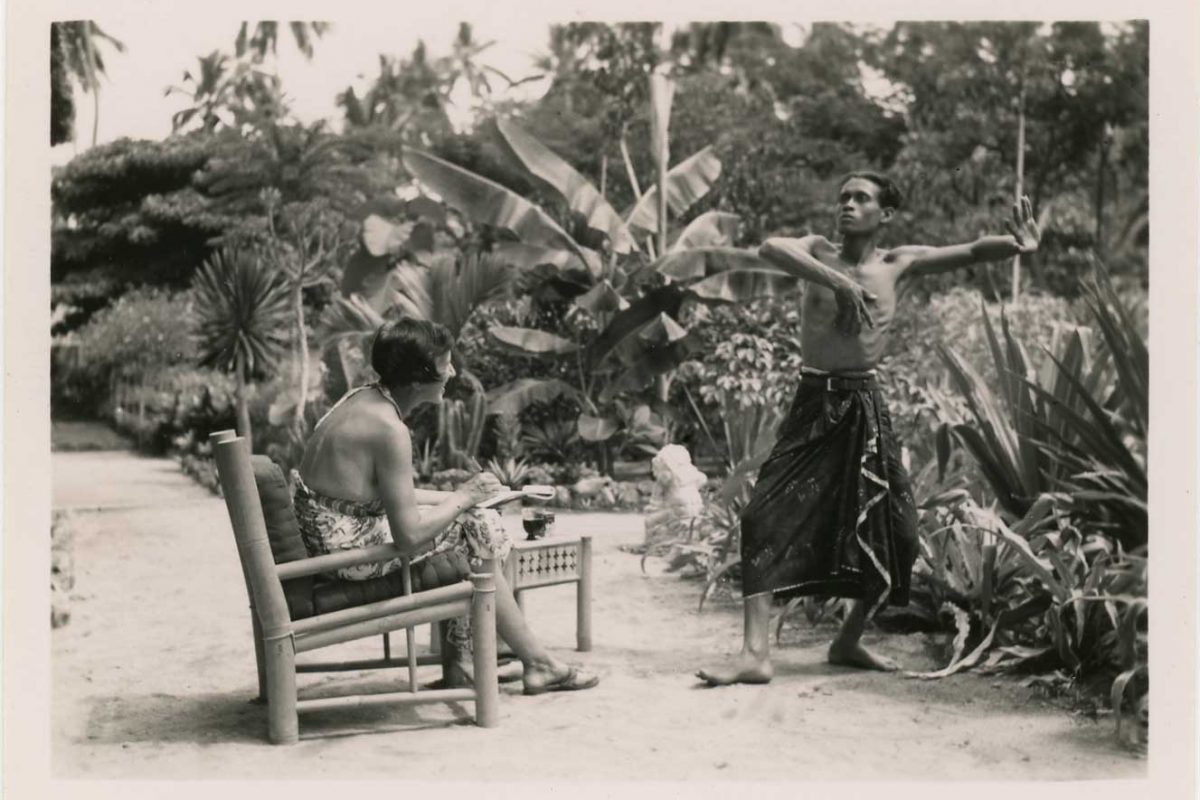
[192,248,289,446]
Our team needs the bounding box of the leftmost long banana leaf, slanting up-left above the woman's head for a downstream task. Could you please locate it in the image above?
[401,148,601,276]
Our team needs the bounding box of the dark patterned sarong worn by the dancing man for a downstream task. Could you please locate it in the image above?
[742,369,917,614]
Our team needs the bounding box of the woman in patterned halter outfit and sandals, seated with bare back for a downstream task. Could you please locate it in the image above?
[293,319,599,694]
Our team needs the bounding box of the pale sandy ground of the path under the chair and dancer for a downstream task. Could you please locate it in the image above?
[52,452,1146,781]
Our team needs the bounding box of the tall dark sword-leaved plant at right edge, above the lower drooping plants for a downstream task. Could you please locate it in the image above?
[938,271,1150,549]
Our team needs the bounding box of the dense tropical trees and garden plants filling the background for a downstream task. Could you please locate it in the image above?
[50,22,1150,743]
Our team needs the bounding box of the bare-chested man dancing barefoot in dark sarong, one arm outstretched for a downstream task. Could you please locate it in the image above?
[697,172,1039,686]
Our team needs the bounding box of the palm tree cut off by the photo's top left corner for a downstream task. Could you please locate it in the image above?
[50,19,125,146]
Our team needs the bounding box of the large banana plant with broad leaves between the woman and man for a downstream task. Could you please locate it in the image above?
[393,113,794,471]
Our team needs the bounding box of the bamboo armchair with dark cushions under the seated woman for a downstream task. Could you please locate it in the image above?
[210,431,499,744]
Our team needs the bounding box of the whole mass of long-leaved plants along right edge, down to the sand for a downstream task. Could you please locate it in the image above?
[892,270,1148,743]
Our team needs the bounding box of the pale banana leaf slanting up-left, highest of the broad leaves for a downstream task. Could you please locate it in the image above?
[497,120,637,254]
